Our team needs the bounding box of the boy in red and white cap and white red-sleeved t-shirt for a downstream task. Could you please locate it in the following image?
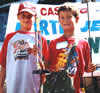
[0,2,48,93]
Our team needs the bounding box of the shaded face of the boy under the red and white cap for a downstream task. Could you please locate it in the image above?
[18,12,33,31]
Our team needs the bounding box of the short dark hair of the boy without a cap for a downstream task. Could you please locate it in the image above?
[58,3,79,18]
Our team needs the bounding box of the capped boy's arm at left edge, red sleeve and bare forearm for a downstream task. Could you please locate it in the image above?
[0,32,16,93]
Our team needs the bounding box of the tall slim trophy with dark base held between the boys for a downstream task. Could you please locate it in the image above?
[32,16,49,74]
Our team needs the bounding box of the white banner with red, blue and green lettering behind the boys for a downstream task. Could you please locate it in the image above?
[6,2,100,64]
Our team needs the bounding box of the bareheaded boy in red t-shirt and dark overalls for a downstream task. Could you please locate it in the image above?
[44,4,96,93]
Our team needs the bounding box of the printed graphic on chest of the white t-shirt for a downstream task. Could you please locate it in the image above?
[13,40,30,60]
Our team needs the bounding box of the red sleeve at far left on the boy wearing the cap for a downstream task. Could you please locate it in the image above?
[0,33,15,68]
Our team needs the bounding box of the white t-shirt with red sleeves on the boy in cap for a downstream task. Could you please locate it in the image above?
[0,32,48,93]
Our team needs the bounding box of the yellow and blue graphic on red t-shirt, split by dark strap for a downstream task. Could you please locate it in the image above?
[56,48,78,74]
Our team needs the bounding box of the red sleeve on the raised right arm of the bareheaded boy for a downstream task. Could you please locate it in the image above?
[76,41,91,75]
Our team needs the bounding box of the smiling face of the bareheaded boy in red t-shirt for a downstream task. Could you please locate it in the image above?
[59,11,78,36]
